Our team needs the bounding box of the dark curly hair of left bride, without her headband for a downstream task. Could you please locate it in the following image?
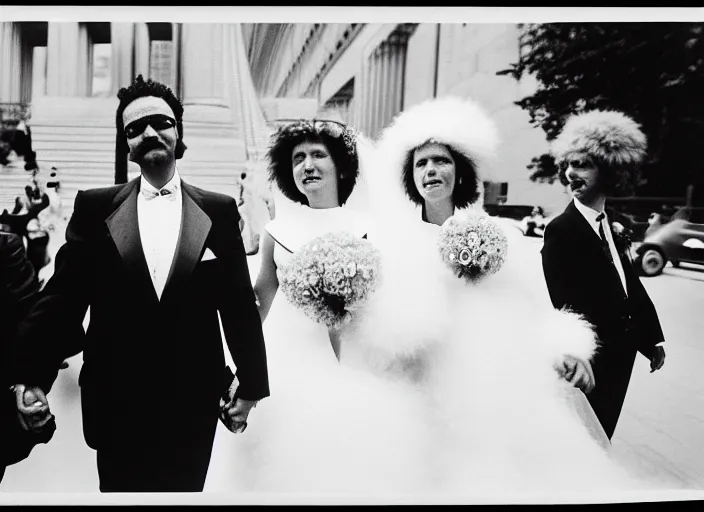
[267,129,359,205]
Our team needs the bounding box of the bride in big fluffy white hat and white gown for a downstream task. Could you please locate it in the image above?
[341,98,638,493]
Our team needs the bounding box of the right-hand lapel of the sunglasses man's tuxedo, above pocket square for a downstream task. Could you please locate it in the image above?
[161,181,213,302]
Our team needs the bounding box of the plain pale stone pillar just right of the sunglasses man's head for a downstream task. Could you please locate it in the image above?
[180,23,227,107]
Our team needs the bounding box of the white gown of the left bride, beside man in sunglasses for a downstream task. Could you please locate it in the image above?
[205,206,429,499]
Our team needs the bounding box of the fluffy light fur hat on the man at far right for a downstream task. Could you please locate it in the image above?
[551,110,647,167]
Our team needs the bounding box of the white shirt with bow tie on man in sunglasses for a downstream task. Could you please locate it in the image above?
[137,169,183,300]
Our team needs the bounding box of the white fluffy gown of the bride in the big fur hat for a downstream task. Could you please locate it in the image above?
[346,212,647,497]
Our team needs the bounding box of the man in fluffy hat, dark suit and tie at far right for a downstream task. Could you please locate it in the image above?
[542,111,665,439]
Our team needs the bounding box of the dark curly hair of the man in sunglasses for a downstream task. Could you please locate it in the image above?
[115,75,186,183]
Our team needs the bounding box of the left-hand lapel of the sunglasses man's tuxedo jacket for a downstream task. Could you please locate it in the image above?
[105,179,158,301]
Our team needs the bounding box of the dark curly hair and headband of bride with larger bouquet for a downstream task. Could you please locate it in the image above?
[267,119,359,205]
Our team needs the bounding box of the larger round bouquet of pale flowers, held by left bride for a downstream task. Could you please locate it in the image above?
[280,233,381,327]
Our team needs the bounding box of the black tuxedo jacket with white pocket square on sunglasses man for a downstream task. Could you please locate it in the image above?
[14,179,269,448]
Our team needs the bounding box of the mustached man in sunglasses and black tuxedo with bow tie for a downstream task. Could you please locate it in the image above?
[9,75,269,492]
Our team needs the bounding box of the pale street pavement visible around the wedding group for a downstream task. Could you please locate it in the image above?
[0,228,704,502]
